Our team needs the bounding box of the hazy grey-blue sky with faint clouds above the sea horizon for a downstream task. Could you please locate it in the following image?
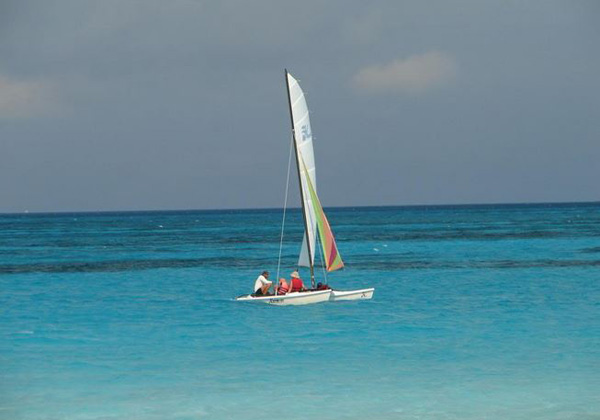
[0,0,600,212]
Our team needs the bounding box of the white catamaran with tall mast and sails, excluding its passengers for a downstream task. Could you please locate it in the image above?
[236,70,375,305]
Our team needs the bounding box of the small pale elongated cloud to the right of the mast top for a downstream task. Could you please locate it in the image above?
[353,51,458,94]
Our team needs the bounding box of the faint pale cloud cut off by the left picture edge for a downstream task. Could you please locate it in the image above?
[0,75,54,119]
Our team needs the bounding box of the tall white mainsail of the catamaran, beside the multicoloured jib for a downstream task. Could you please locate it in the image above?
[287,73,317,267]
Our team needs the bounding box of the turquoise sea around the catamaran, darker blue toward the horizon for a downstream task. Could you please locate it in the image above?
[0,203,600,420]
